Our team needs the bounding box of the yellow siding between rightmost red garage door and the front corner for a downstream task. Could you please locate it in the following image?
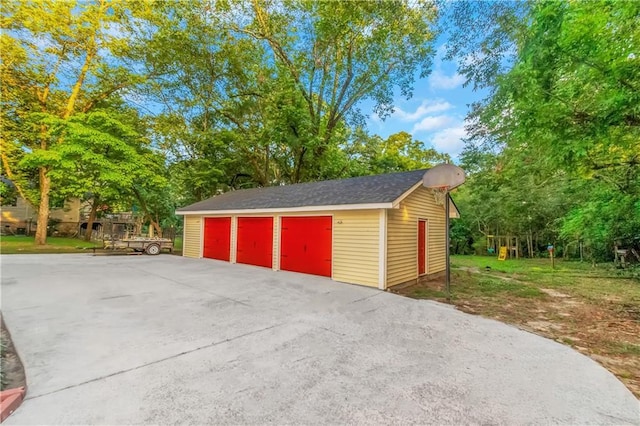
[333,210,380,287]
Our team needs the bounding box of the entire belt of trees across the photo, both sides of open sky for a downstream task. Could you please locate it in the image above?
[0,0,640,259]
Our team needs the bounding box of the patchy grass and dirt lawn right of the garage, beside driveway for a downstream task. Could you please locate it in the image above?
[396,256,640,397]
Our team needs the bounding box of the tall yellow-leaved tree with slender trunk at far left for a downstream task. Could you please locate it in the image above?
[0,0,150,244]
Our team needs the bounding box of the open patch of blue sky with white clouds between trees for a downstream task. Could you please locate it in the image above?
[362,44,483,160]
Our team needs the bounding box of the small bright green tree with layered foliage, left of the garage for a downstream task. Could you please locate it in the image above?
[47,102,162,241]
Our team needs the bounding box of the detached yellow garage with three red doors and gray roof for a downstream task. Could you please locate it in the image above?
[177,170,459,289]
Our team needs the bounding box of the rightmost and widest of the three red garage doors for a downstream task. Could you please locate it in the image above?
[280,216,333,277]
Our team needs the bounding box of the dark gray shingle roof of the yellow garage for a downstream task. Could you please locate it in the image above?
[178,170,426,213]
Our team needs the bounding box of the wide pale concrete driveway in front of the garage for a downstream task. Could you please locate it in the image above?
[0,255,640,424]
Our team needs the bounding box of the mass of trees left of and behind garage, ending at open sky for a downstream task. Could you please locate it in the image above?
[0,0,445,244]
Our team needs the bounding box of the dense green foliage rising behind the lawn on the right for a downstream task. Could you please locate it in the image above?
[452,1,640,255]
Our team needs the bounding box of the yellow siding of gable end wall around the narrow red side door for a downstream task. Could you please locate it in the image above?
[387,187,445,286]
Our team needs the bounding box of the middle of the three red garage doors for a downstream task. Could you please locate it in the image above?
[236,217,273,268]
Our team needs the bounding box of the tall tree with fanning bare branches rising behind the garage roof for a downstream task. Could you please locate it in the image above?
[227,1,436,182]
